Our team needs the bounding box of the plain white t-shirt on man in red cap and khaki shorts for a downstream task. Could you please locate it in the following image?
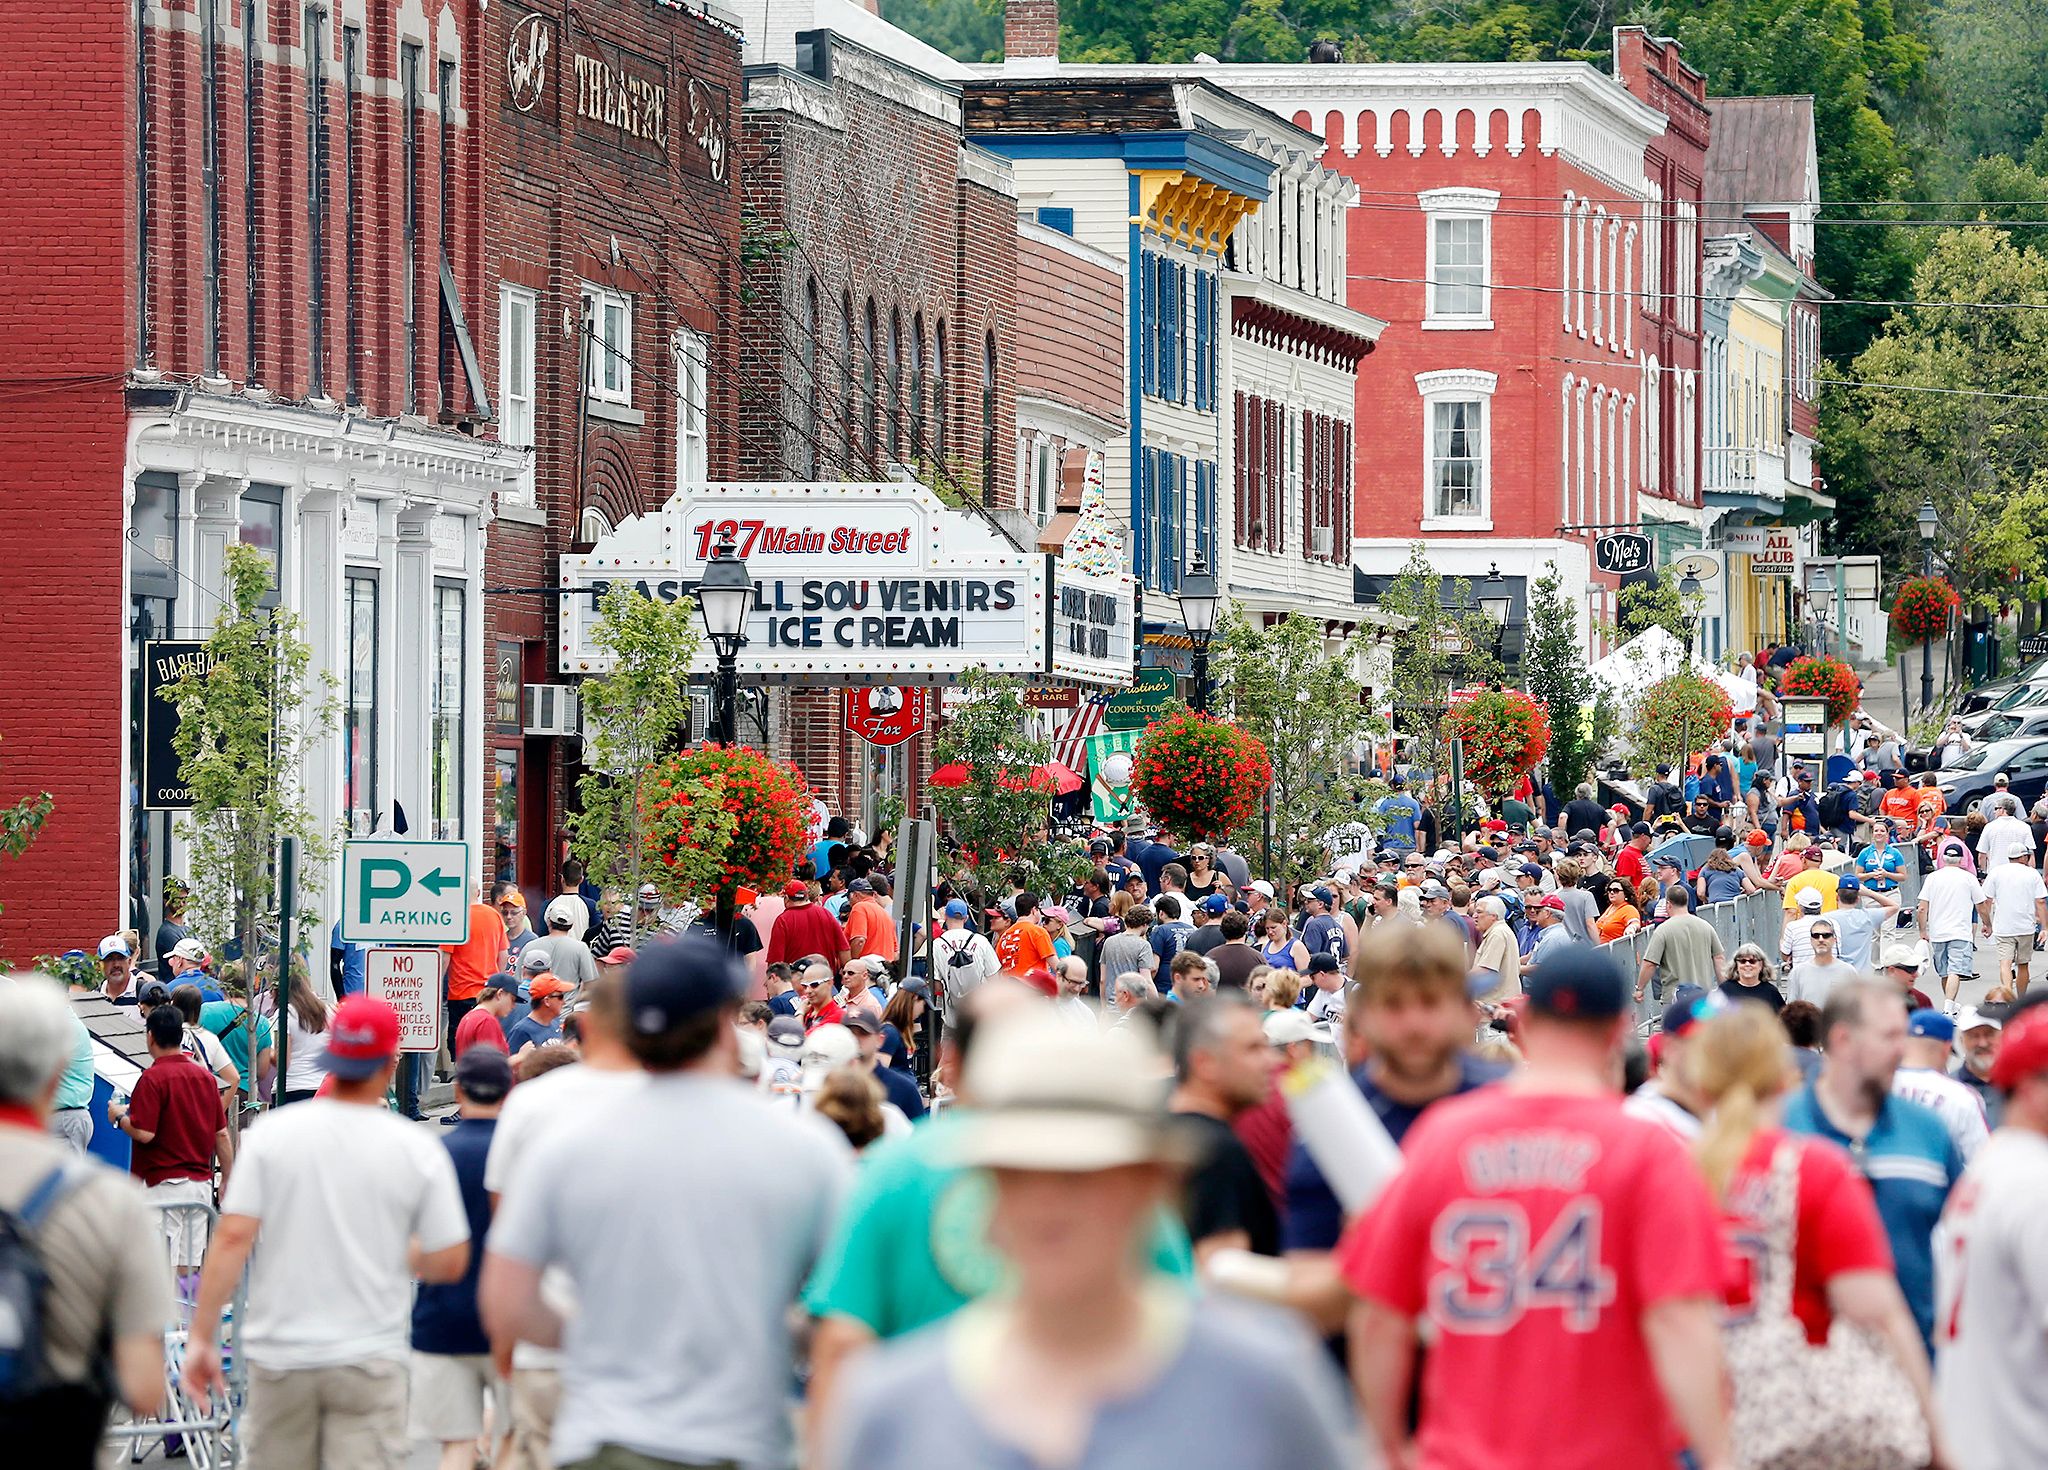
[221,1097,469,1370]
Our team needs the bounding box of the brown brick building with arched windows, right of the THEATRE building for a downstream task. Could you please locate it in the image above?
[735,17,1032,817]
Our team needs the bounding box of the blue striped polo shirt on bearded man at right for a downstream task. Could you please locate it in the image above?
[1784,1085,1962,1347]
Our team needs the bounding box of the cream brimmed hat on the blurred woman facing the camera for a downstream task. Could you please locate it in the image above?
[958,1009,1186,1173]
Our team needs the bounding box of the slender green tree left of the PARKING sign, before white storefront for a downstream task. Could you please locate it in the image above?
[166,543,334,974]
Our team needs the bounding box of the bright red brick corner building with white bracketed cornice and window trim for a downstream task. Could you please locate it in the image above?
[1202,43,1704,649]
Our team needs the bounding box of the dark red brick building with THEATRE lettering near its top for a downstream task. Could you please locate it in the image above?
[477,0,760,893]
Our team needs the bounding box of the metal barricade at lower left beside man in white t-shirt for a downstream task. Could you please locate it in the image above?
[106,1200,248,1470]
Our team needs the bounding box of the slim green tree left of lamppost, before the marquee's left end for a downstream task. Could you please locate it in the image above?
[567,581,721,937]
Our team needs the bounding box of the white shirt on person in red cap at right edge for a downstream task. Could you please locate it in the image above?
[1933,1128,2048,1470]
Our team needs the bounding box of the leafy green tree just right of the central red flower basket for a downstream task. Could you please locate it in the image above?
[1208,612,1386,893]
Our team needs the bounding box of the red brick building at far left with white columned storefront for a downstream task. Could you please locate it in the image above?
[0,0,524,956]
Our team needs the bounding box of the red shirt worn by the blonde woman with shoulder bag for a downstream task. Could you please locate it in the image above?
[1720,1128,1892,1343]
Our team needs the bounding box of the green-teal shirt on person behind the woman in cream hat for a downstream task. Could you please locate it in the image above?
[803,1112,1194,1337]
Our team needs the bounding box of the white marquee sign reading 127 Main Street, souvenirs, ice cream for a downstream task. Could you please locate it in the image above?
[559,483,1130,686]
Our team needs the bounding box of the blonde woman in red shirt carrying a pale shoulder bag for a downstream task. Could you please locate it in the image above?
[1679,1001,1948,1464]
